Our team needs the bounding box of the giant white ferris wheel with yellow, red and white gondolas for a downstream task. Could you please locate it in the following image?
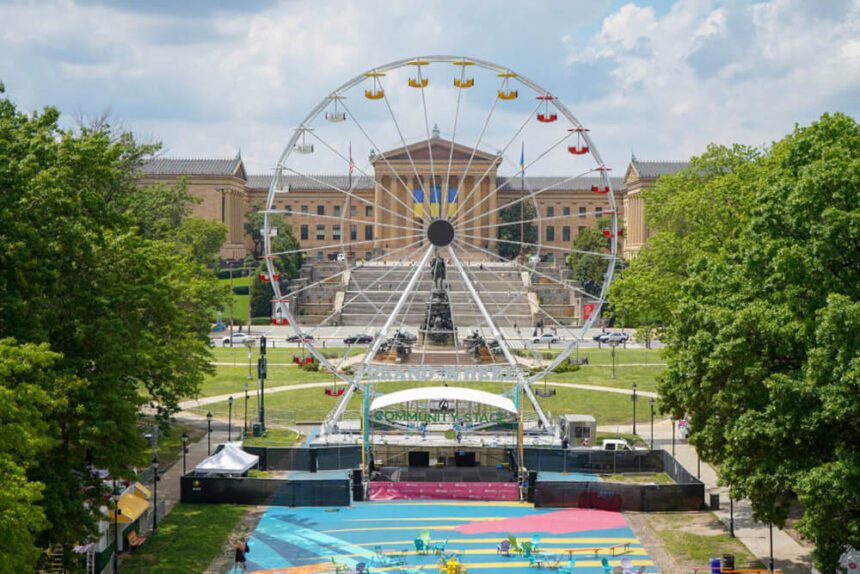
[263,56,620,434]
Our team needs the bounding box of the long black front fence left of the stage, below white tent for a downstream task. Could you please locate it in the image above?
[181,475,351,506]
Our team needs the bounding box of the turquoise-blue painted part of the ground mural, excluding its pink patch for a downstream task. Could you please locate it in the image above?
[248,502,657,574]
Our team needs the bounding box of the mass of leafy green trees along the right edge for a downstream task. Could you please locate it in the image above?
[613,114,860,572]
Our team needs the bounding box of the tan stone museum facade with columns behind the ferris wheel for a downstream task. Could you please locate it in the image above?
[141,146,686,261]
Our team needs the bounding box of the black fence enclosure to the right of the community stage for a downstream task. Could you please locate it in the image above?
[523,449,705,512]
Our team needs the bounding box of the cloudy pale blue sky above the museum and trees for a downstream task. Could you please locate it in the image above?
[0,0,860,175]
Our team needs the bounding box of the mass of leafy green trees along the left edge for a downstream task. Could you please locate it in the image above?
[0,85,225,572]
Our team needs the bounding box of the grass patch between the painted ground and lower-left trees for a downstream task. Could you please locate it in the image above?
[120,503,246,574]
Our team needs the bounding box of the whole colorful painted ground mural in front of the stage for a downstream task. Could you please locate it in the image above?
[248,501,658,574]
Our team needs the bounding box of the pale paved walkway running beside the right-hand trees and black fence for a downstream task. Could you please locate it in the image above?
[598,420,812,574]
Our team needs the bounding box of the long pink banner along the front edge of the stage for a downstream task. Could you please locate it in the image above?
[369,481,520,501]
